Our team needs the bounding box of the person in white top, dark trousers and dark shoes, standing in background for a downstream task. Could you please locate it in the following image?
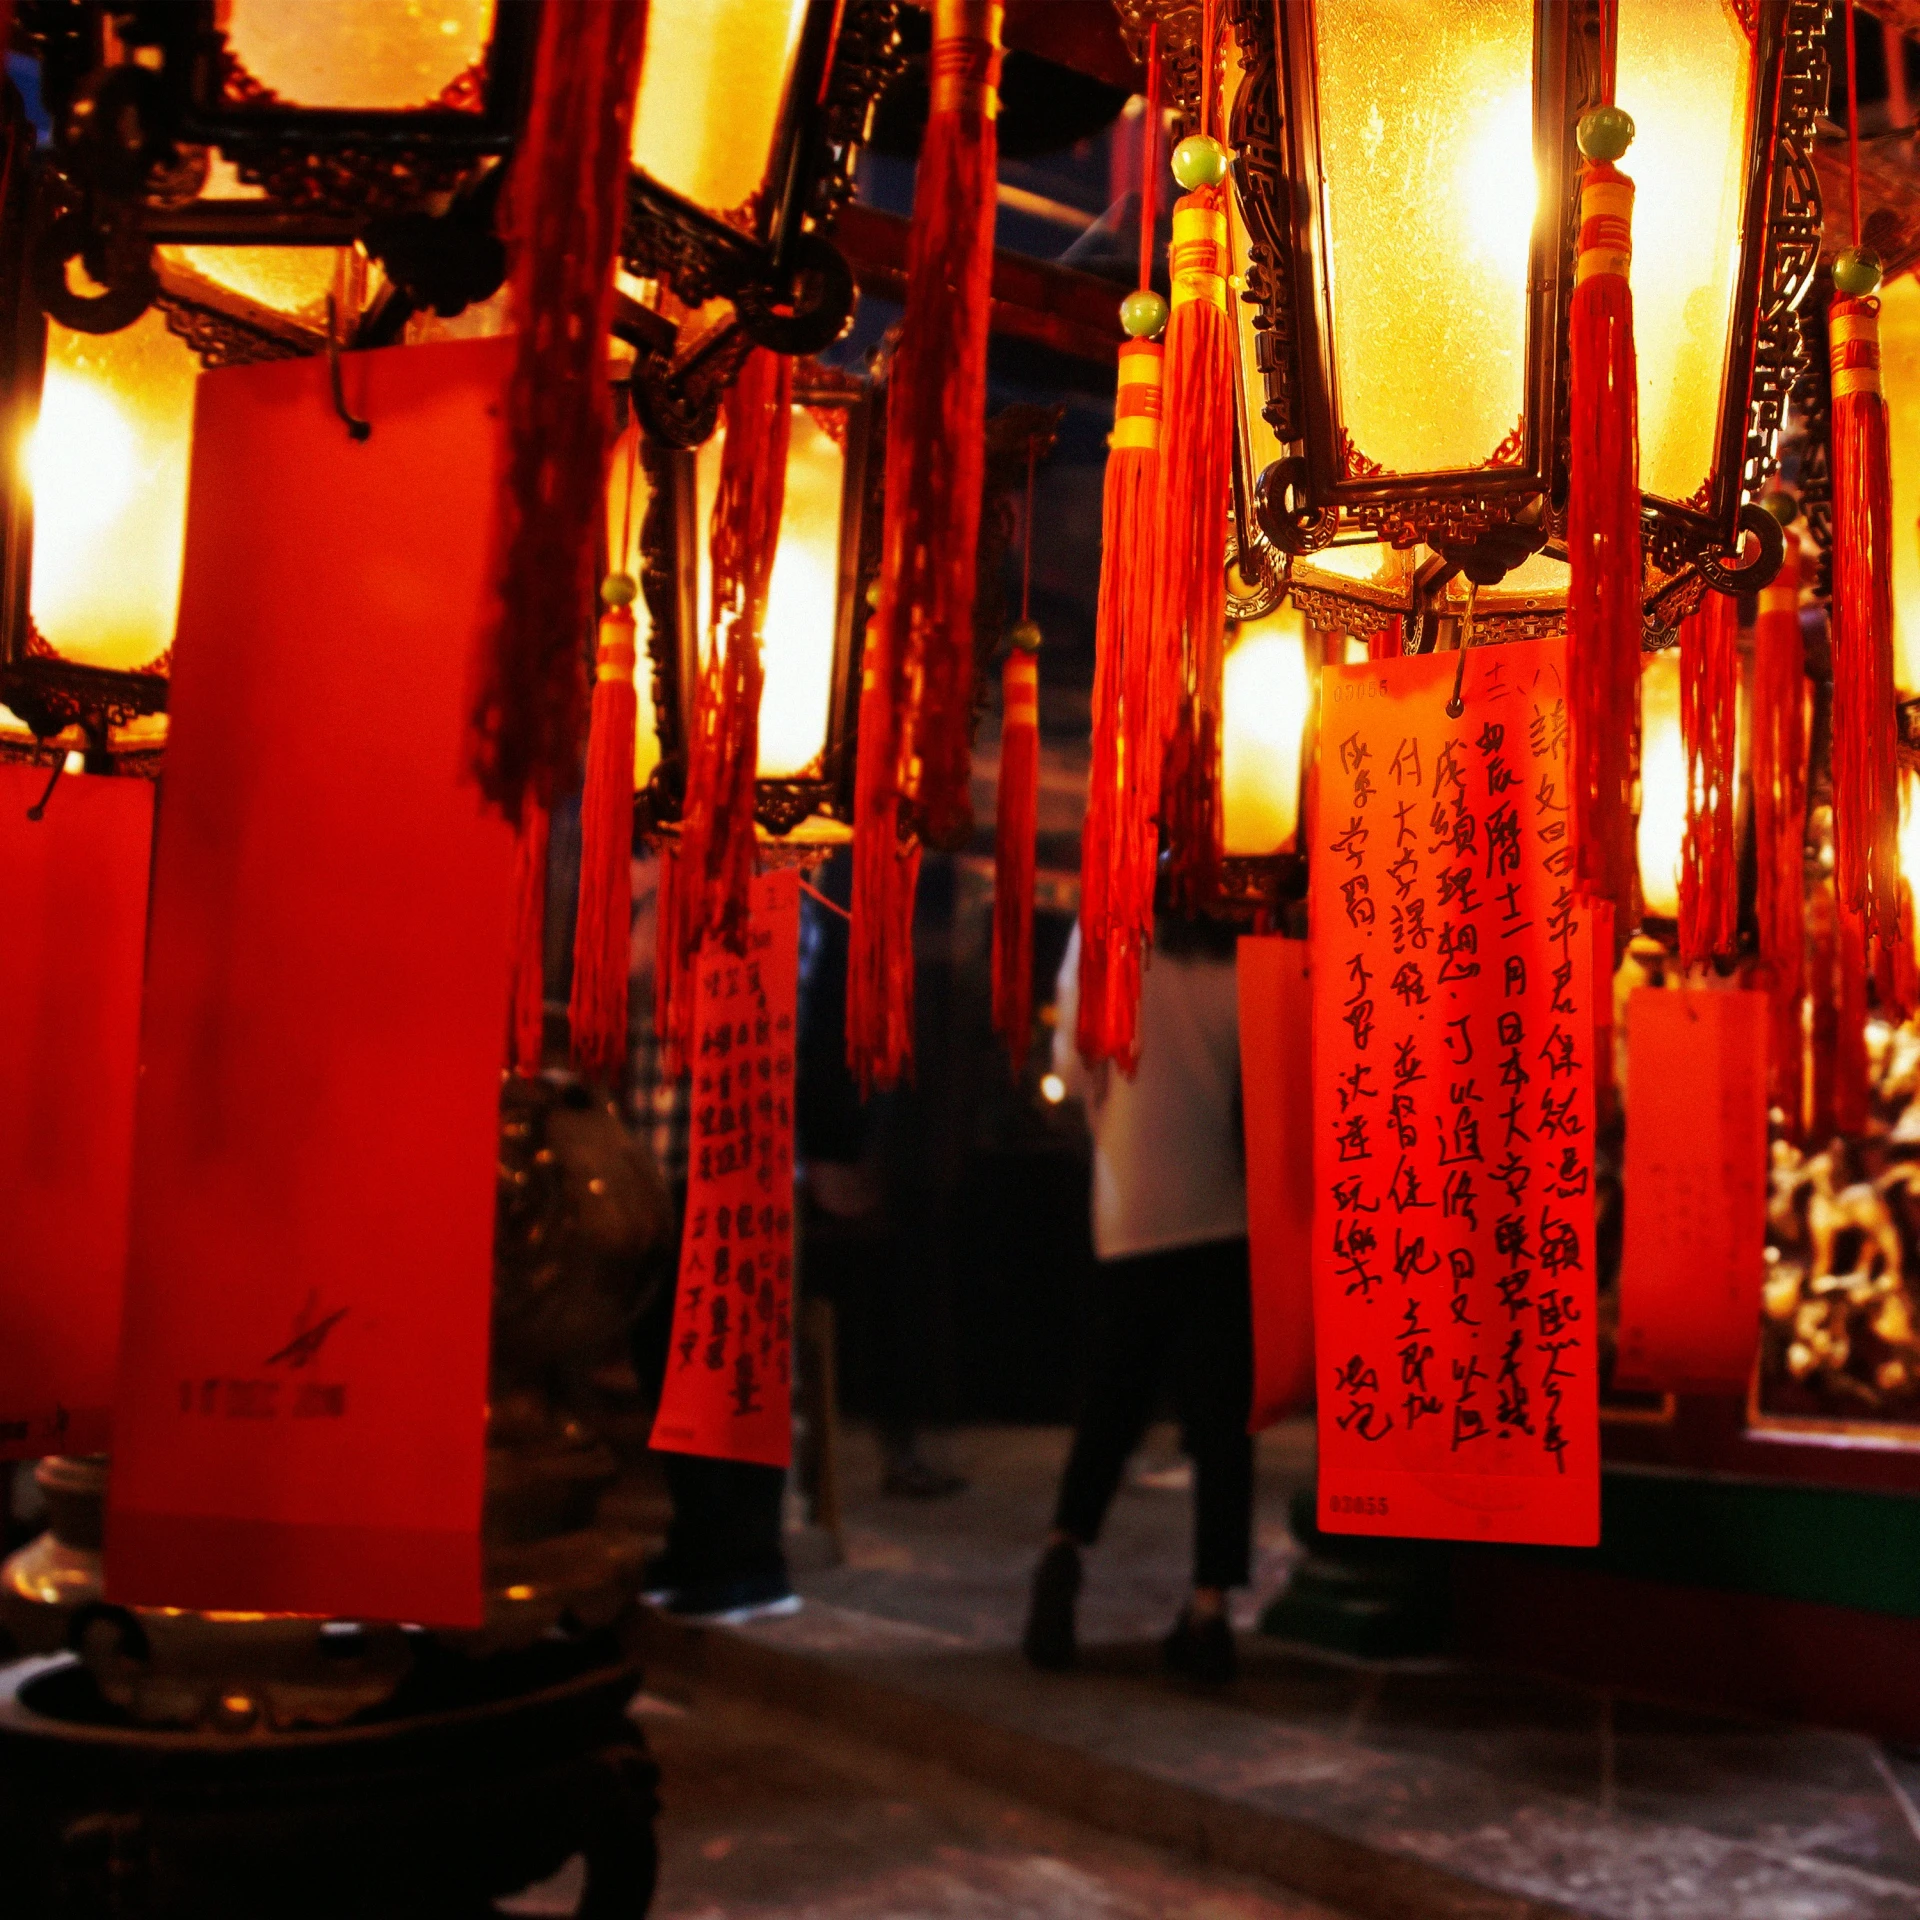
[1021,914,1254,1682]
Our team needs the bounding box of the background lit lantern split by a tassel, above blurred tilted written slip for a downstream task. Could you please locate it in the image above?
[625,363,879,837]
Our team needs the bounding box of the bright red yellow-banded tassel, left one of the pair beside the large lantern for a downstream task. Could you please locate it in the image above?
[1075,340,1165,1073]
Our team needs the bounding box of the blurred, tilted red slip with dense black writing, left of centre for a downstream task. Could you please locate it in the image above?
[653,874,801,1467]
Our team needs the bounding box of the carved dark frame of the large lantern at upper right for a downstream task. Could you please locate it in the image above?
[1116,0,1828,647]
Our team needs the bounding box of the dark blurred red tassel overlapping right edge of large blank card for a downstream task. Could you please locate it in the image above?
[467,0,647,820]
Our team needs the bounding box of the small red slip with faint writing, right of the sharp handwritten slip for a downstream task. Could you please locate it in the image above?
[1615,987,1766,1394]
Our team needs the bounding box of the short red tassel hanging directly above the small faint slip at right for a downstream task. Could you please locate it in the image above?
[1680,593,1740,968]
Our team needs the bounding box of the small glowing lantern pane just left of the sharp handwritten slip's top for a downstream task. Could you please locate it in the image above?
[1221,605,1311,854]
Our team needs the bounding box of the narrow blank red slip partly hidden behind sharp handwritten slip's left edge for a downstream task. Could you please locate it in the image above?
[1238,935,1313,1432]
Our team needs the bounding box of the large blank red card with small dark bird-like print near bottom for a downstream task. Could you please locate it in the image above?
[108,340,513,1624]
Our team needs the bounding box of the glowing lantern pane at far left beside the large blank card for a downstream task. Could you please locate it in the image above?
[23,309,200,668]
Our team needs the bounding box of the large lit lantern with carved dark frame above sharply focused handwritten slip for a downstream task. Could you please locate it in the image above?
[1121,0,1826,645]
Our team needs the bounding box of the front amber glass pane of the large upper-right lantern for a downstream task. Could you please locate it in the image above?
[1311,0,1536,474]
